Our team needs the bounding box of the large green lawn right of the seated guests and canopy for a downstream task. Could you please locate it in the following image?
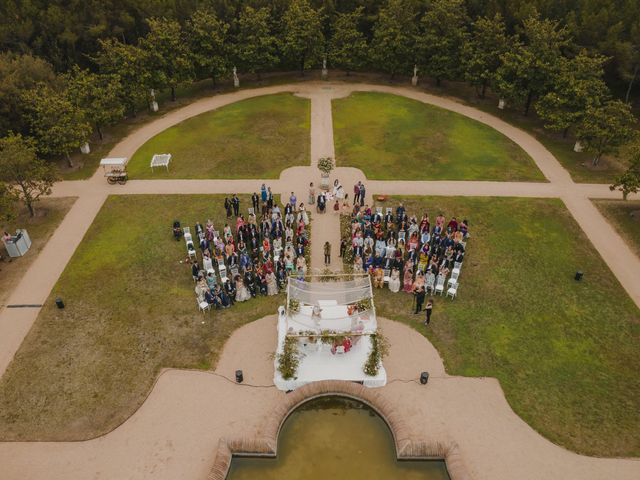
[352,197,640,456]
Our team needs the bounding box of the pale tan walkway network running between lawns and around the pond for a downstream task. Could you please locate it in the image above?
[0,82,640,479]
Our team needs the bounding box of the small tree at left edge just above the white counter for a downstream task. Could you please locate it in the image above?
[0,134,57,217]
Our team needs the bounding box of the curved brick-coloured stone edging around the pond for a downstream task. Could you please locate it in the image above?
[207,380,472,480]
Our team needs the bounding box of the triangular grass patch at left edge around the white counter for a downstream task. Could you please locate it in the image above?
[0,197,76,308]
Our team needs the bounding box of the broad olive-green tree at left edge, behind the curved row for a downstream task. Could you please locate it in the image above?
[0,53,57,136]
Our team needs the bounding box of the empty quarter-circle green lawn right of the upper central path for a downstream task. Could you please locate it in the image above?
[333,92,544,181]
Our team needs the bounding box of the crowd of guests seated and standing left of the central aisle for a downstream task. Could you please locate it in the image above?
[173,184,309,308]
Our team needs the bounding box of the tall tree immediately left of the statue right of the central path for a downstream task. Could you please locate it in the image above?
[371,0,417,78]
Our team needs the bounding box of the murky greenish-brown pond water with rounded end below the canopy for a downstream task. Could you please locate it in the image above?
[227,397,449,480]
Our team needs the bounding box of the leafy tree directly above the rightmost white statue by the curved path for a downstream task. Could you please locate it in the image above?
[536,50,609,137]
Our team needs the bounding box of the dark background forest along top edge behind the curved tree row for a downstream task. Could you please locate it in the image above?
[0,0,640,95]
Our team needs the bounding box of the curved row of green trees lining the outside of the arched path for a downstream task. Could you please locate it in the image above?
[0,0,635,217]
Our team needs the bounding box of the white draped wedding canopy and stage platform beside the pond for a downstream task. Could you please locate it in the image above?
[273,275,387,391]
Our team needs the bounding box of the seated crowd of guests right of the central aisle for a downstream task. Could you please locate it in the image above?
[340,202,469,306]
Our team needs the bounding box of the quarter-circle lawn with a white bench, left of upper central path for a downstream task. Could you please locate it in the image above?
[128,93,311,179]
